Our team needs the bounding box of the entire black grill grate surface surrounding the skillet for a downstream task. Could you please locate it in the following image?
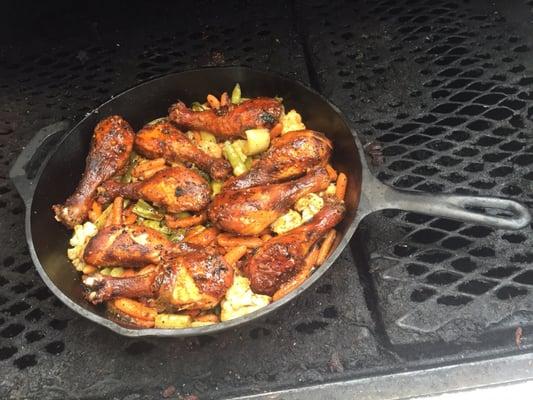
[0,0,533,399]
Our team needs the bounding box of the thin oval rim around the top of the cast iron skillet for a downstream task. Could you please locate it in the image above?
[25,65,368,337]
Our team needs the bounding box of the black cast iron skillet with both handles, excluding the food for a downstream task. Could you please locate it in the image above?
[10,67,531,336]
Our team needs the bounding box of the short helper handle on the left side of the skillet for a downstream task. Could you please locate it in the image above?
[9,121,70,206]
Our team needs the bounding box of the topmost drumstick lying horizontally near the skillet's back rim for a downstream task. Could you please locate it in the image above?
[169,97,283,139]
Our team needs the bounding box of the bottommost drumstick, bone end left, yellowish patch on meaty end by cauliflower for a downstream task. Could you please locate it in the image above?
[83,247,233,311]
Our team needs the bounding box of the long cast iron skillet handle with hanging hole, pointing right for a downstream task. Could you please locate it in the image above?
[361,174,531,229]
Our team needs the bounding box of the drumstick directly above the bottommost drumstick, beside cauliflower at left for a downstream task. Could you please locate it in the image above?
[83,225,189,268]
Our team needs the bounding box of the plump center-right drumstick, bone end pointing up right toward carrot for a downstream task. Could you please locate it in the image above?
[208,167,329,235]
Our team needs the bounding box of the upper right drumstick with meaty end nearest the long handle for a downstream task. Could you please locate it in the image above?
[223,130,332,190]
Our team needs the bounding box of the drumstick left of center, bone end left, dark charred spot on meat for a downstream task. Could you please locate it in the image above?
[99,165,211,213]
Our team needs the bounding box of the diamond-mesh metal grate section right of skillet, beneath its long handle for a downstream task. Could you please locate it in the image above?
[302,0,533,344]
